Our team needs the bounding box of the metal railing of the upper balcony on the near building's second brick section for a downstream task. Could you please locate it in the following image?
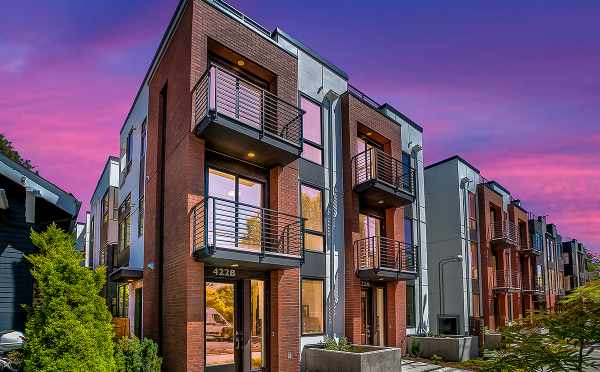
[352,147,415,195]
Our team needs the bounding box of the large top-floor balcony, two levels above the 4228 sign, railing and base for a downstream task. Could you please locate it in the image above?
[192,66,304,167]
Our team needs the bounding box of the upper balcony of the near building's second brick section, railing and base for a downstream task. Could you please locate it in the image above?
[352,148,415,208]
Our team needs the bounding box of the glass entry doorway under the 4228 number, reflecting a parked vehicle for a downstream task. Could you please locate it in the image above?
[204,268,268,372]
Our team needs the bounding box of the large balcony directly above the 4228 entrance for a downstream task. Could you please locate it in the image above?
[190,197,304,270]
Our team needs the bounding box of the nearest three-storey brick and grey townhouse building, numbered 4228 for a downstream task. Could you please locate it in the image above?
[91,0,429,371]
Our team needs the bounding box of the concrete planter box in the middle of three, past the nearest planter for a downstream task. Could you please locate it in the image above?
[408,336,479,362]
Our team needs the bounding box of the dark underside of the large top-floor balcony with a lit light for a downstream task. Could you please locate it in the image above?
[194,112,302,168]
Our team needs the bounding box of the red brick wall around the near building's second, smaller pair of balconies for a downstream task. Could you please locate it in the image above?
[341,94,406,346]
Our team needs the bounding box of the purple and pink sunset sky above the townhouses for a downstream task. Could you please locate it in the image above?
[0,0,600,252]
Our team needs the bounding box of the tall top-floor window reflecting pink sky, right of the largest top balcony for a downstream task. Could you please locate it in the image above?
[300,96,323,165]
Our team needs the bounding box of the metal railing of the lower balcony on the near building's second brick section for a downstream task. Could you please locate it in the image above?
[354,236,417,273]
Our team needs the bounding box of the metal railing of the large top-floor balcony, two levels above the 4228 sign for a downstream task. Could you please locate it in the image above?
[192,65,304,147]
